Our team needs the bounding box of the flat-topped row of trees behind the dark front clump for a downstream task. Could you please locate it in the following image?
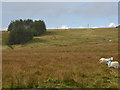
[8,19,46,36]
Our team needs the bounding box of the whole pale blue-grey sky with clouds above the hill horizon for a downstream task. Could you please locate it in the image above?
[2,2,118,29]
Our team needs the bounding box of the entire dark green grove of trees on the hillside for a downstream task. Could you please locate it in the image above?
[7,19,46,45]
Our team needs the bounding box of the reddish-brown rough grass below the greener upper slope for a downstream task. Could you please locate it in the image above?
[2,28,118,88]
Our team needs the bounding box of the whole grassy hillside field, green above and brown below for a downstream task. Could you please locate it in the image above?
[2,28,118,88]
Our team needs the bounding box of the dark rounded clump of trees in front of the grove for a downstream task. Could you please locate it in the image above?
[7,25,33,45]
